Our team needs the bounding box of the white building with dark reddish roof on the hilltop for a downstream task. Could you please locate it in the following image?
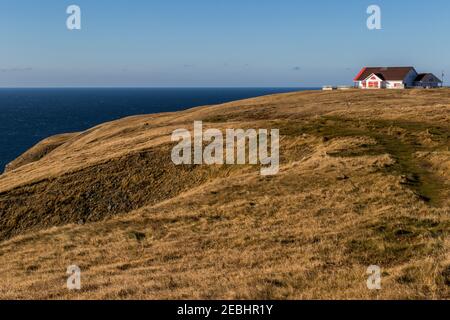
[354,67,442,89]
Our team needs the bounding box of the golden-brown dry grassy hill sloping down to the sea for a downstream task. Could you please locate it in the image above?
[0,89,450,299]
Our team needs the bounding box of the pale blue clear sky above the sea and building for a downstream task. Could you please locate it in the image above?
[0,0,450,87]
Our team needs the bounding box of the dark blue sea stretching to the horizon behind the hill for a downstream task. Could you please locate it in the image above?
[0,88,313,171]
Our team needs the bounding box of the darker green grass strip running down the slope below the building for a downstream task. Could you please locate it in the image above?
[276,116,450,206]
